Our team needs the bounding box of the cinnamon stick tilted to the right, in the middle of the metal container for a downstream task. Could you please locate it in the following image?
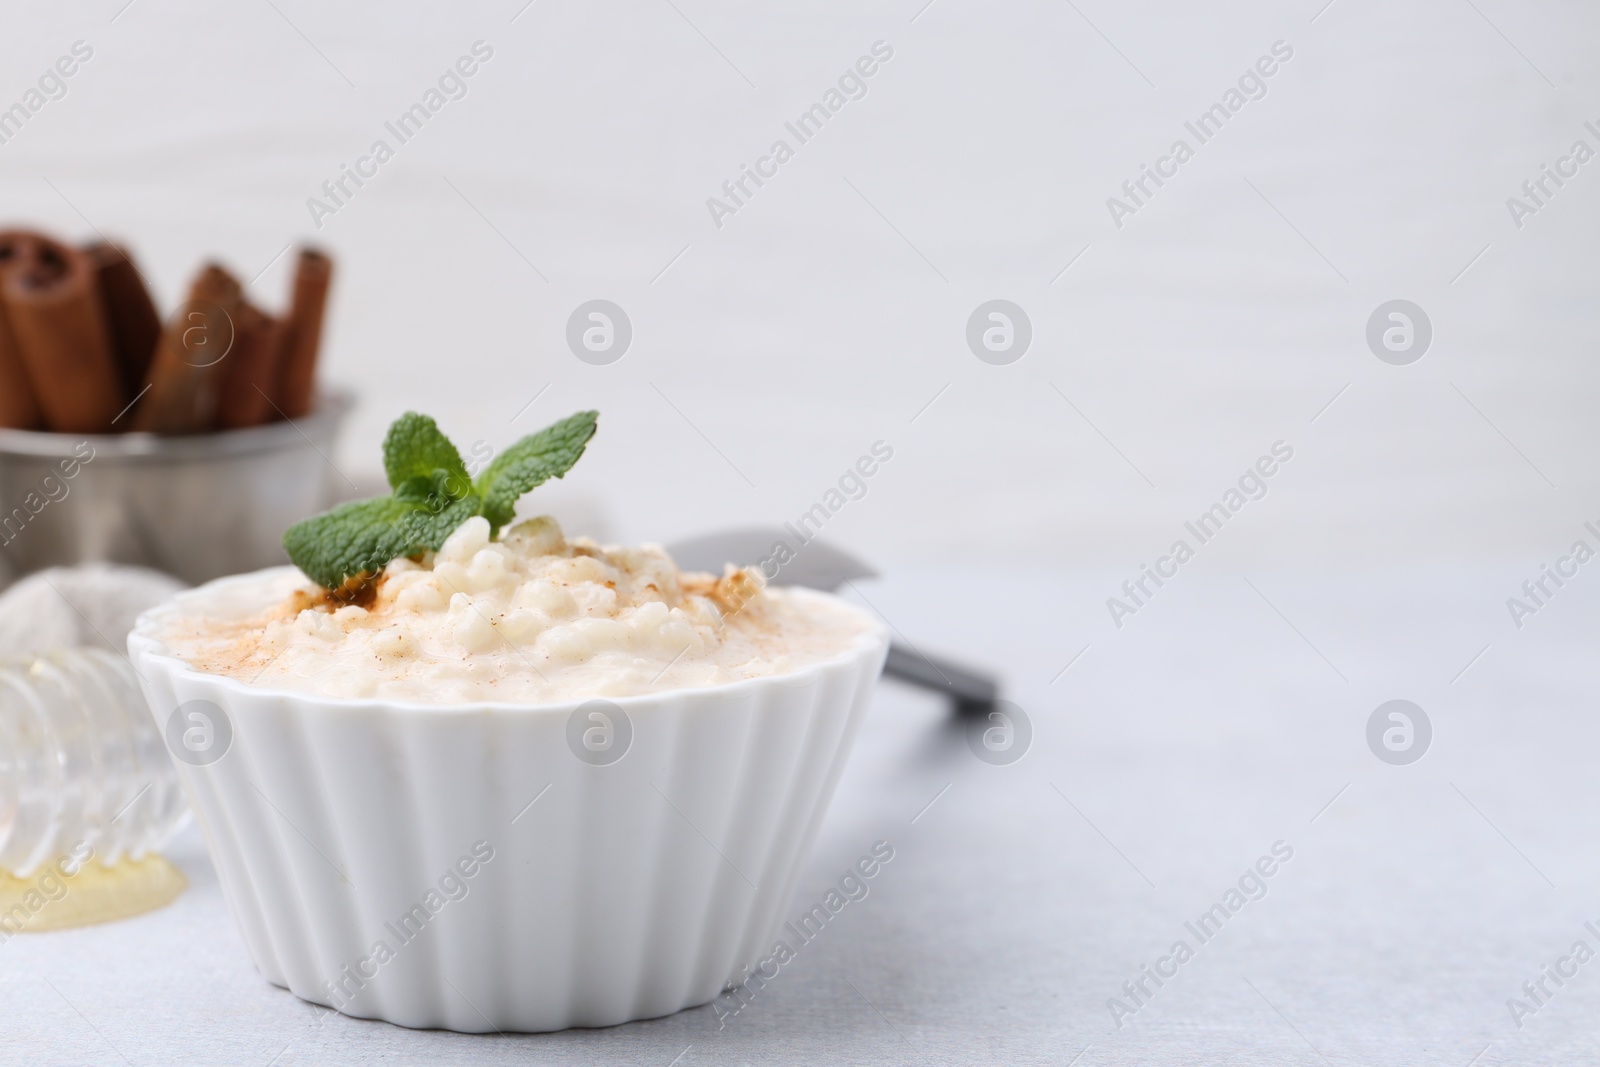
[133,262,242,434]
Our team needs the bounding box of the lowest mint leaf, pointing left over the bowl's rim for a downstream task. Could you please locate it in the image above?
[283,496,478,589]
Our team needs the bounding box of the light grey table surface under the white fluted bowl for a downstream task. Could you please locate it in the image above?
[0,565,1600,1067]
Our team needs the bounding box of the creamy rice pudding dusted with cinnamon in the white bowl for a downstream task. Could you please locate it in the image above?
[160,517,874,704]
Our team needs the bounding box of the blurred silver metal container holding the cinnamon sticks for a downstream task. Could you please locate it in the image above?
[0,392,352,584]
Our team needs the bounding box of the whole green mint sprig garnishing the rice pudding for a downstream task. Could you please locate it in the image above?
[283,411,600,593]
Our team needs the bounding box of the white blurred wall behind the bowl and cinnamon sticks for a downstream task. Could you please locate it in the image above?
[0,0,1600,573]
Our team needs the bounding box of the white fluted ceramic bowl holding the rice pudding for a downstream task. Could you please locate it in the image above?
[128,568,888,1032]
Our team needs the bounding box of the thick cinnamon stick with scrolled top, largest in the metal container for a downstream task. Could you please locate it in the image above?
[0,238,128,434]
